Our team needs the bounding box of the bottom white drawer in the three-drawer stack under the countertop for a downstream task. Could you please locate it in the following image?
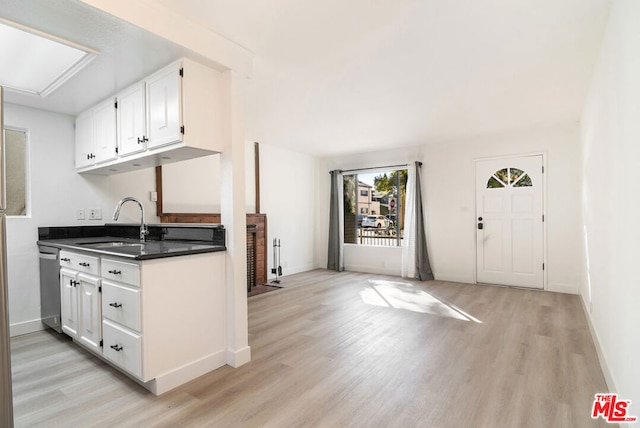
[102,320,142,378]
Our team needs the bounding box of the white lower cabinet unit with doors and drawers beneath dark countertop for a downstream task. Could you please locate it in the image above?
[60,251,227,394]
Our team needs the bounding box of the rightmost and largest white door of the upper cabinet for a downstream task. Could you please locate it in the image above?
[146,64,182,148]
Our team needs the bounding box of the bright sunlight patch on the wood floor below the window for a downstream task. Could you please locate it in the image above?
[360,280,482,323]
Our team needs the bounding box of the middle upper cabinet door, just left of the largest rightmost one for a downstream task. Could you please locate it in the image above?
[117,83,147,156]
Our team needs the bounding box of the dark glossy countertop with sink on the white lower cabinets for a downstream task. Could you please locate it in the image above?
[38,224,227,260]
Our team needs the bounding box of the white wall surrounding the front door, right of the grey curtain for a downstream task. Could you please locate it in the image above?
[422,124,581,294]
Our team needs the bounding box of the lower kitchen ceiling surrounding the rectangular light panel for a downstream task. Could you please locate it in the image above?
[0,0,193,116]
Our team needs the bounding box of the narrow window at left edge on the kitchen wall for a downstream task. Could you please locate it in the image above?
[4,129,27,216]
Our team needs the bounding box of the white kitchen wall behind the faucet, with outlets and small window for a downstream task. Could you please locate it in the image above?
[4,104,157,335]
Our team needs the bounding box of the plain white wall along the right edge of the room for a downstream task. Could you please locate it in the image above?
[581,0,640,410]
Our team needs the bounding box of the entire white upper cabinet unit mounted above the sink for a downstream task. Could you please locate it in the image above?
[76,58,224,175]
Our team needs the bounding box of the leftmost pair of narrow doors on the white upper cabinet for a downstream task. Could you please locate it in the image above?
[76,98,117,168]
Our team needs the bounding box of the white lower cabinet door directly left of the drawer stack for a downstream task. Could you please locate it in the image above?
[78,273,102,351]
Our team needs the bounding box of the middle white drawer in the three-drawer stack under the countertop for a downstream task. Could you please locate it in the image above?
[102,281,141,331]
